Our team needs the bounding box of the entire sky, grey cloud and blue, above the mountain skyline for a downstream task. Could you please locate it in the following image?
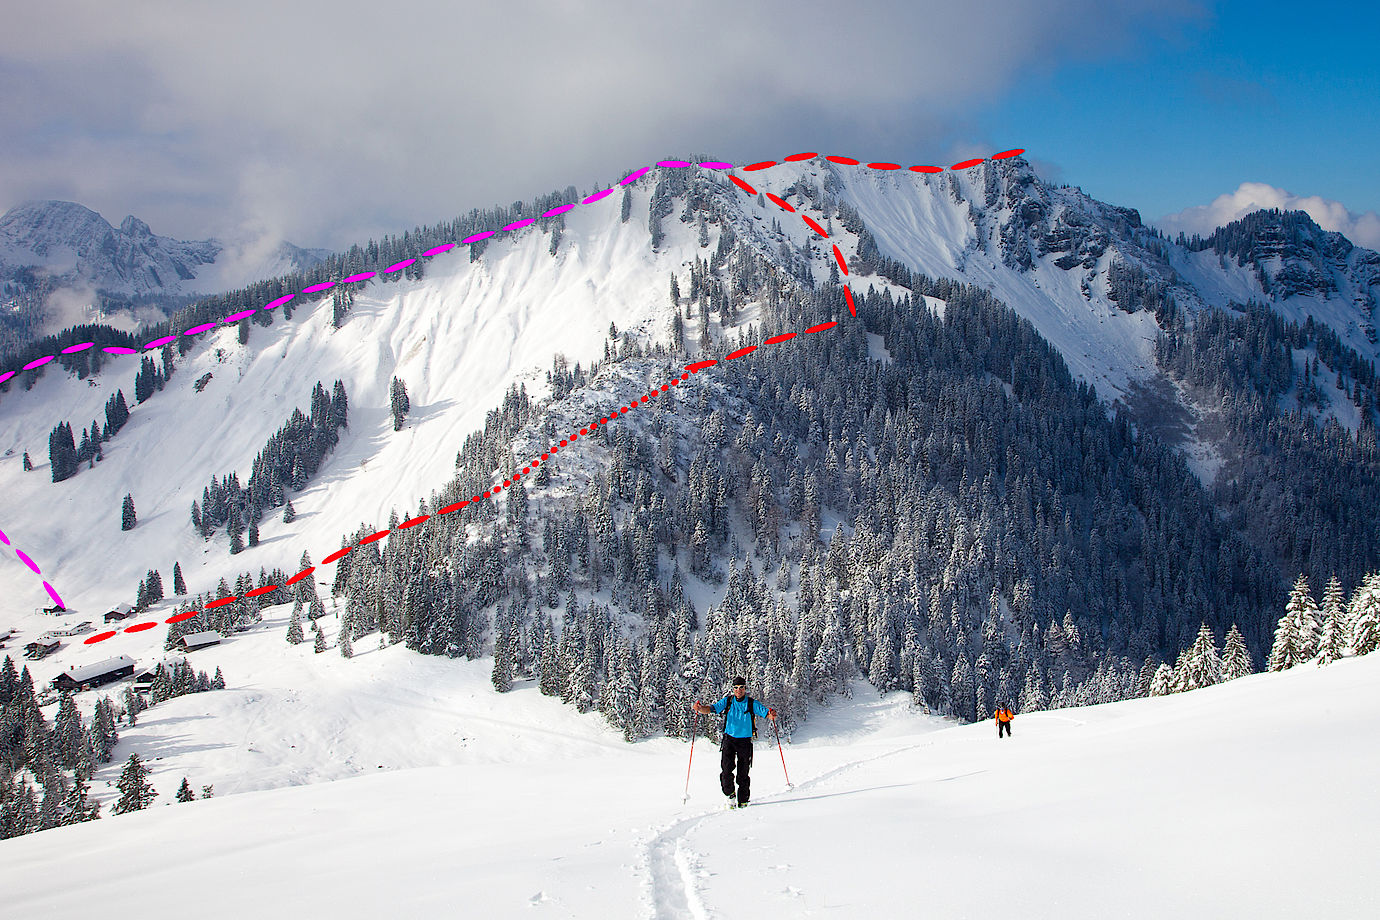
[0,0,1380,248]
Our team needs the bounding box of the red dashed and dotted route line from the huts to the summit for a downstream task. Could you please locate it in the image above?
[78,150,1024,646]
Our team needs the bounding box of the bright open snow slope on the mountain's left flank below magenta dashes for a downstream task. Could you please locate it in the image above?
[0,176,700,640]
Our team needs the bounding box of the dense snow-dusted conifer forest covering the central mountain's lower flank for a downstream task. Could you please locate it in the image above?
[302,206,1380,738]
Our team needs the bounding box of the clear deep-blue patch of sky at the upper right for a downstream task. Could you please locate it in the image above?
[980,1,1380,227]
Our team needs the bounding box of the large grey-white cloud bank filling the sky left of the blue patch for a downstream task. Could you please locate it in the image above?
[0,0,1201,246]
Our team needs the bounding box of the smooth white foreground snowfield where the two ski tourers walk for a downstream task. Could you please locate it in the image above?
[0,607,1380,920]
